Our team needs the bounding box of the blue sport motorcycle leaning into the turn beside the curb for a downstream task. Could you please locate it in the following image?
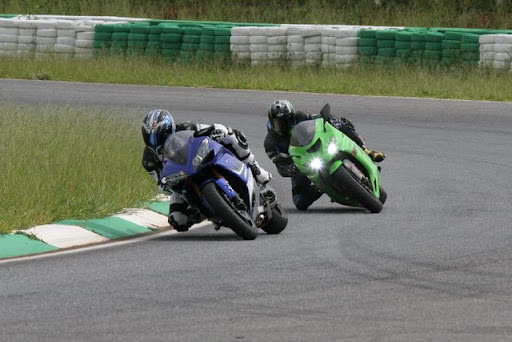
[160,131,288,240]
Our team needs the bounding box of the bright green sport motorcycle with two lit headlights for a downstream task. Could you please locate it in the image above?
[288,104,387,213]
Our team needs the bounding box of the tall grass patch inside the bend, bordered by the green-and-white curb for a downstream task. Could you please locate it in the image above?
[0,104,155,233]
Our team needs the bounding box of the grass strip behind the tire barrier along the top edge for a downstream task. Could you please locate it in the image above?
[0,0,512,29]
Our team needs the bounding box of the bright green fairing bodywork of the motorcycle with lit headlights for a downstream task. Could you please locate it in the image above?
[288,118,380,206]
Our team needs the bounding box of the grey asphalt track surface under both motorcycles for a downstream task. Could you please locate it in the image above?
[0,80,512,341]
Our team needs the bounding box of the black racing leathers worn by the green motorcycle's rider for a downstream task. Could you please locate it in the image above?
[264,111,364,210]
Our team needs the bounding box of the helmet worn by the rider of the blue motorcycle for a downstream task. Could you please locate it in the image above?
[142,109,176,154]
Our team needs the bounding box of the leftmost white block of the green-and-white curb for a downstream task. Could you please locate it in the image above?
[23,224,109,248]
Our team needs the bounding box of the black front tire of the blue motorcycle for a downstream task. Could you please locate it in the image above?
[199,182,258,240]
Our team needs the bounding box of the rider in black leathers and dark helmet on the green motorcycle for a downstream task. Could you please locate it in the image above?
[264,100,385,210]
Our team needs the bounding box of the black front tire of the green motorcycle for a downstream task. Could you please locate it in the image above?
[332,165,382,213]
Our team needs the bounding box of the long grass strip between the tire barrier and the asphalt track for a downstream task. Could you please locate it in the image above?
[0,56,512,101]
